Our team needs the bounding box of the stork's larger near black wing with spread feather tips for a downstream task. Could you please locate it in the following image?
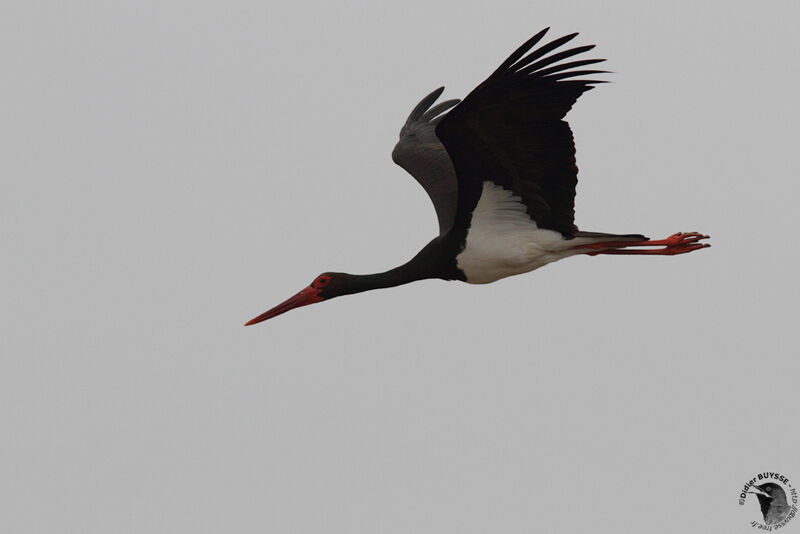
[436,28,607,237]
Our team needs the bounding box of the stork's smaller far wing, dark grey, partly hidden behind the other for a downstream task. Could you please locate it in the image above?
[392,87,460,235]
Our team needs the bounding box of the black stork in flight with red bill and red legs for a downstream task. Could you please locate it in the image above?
[246,28,710,325]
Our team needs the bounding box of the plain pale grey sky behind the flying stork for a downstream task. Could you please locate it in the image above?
[0,0,800,534]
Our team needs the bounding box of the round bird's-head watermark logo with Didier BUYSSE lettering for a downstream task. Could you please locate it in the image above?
[739,472,798,531]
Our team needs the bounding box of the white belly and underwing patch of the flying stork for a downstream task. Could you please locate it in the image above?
[456,181,580,284]
